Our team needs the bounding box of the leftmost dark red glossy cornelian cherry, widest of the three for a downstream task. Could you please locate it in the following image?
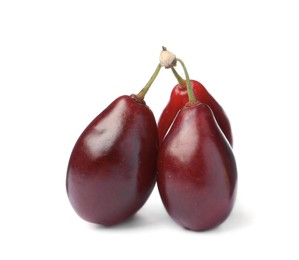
[66,95,158,226]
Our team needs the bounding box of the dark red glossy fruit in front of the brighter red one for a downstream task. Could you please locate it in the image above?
[157,103,237,231]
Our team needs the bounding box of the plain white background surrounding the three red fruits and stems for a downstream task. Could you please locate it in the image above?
[0,0,299,259]
